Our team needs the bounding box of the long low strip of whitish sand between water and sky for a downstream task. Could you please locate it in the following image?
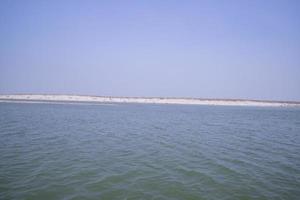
[0,95,300,107]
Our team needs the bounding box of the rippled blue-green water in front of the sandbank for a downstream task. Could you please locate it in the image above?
[0,103,300,200]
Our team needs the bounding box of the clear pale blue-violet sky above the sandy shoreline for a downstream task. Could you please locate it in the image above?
[0,0,300,101]
